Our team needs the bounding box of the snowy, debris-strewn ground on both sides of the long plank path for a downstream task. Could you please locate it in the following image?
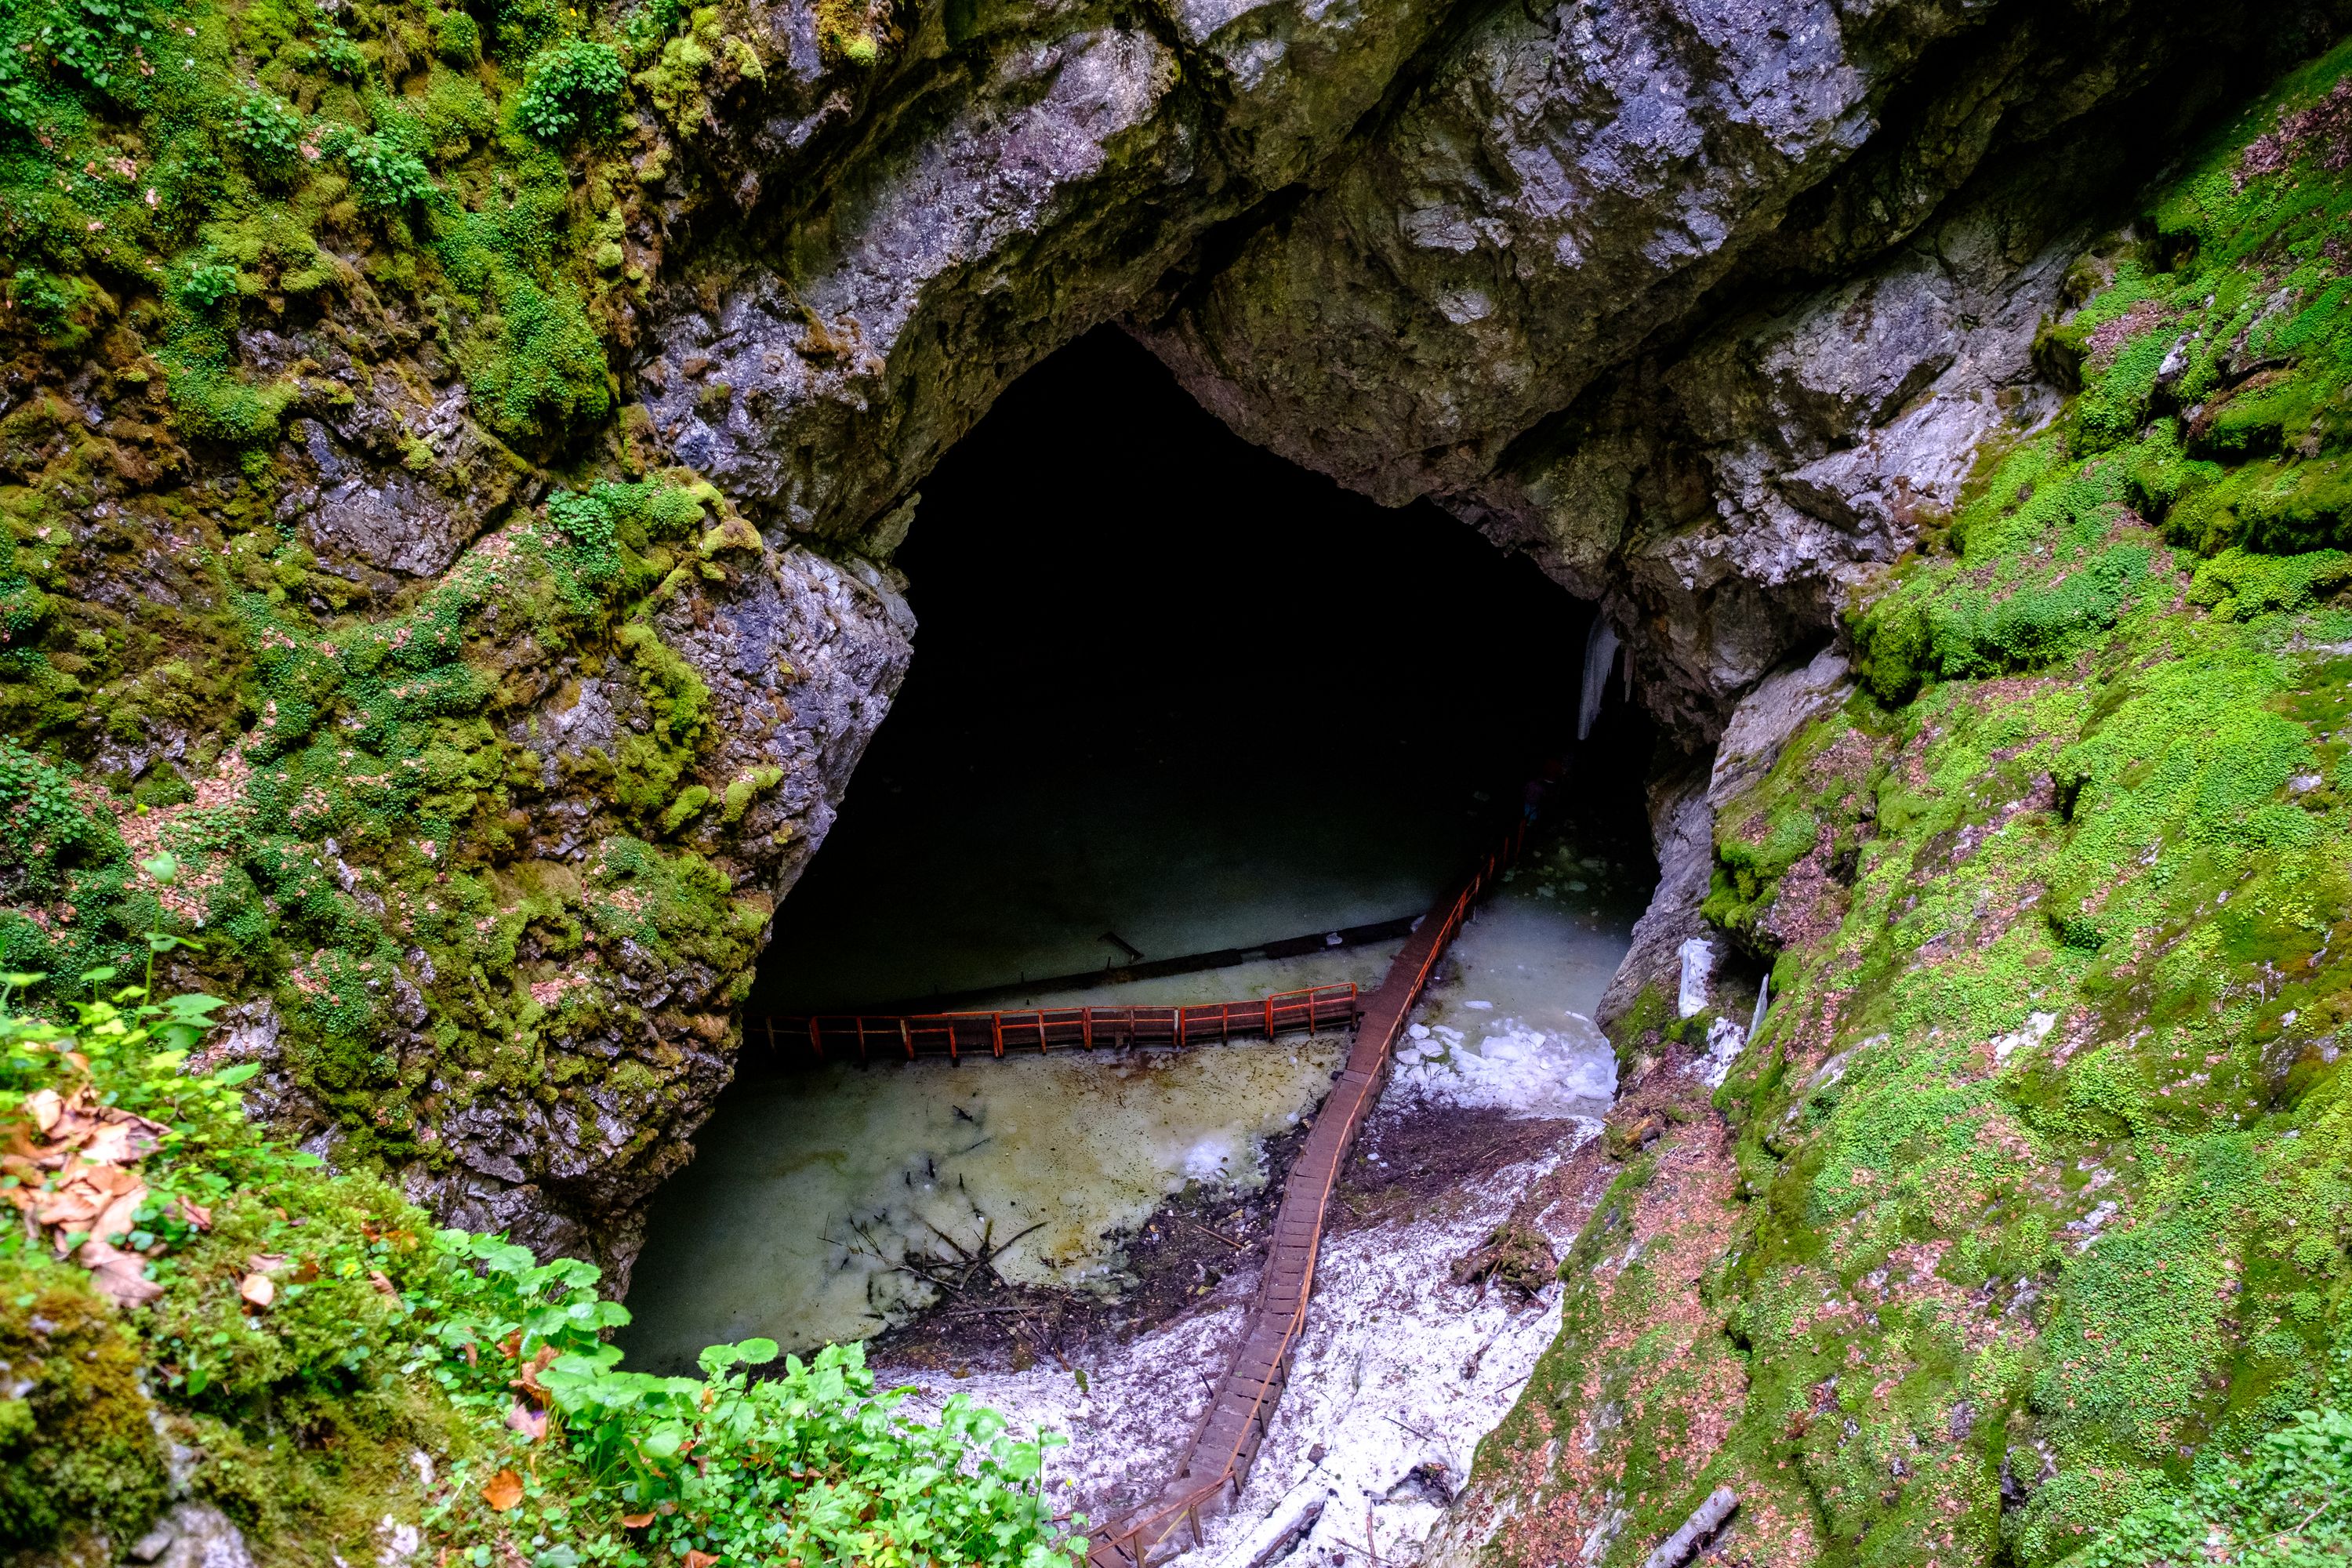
[870,844,1630,1563]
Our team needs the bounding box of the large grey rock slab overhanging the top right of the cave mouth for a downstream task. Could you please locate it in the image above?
[1155,0,1973,501]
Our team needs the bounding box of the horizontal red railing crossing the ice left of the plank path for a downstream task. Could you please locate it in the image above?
[750,982,1362,1062]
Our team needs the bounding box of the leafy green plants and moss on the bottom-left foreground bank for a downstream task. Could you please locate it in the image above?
[0,975,1084,1568]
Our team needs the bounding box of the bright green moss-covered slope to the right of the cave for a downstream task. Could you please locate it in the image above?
[1482,34,2352,1568]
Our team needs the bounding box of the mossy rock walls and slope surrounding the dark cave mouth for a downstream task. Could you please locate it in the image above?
[0,0,2352,1566]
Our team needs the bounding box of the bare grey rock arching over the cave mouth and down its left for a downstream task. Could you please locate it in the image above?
[13,0,2345,1267]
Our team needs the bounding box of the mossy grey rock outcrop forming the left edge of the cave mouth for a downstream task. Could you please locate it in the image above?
[181,520,915,1288]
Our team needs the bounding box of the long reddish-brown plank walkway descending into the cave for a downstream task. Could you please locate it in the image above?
[1087,822,1526,1568]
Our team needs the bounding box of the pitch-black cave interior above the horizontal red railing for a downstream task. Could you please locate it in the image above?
[750,327,1618,1013]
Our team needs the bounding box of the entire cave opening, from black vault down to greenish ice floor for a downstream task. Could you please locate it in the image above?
[628,329,1653,1368]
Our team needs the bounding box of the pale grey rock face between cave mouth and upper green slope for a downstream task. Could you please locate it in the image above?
[1562,194,2072,739]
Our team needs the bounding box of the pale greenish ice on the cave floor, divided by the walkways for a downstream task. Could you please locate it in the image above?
[626,822,1630,1366]
